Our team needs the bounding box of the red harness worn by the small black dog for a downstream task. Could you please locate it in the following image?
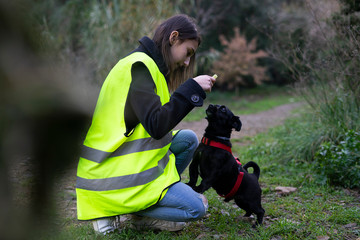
[201,137,244,202]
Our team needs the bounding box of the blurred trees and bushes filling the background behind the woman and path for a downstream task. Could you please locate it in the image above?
[31,0,360,188]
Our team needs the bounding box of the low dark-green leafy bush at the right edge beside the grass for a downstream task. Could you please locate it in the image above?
[314,130,360,188]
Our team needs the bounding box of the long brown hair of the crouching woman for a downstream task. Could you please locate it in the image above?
[153,14,201,91]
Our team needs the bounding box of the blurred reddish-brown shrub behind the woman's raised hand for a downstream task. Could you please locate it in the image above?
[213,28,268,92]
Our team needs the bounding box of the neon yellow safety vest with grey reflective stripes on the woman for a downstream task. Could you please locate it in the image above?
[76,52,180,220]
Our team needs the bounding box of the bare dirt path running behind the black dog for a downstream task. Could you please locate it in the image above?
[176,103,302,139]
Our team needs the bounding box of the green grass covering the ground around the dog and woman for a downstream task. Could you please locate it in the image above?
[43,89,360,239]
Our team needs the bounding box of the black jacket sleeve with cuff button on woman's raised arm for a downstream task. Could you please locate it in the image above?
[125,62,206,139]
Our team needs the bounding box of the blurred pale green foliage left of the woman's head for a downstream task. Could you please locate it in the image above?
[33,0,174,85]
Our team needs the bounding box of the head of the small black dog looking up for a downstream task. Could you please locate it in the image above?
[206,104,242,132]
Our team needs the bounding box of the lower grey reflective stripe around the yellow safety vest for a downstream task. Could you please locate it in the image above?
[76,151,170,191]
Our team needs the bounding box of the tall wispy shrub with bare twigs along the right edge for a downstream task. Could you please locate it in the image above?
[268,1,360,148]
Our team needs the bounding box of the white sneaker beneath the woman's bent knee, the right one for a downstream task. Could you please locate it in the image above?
[130,215,186,232]
